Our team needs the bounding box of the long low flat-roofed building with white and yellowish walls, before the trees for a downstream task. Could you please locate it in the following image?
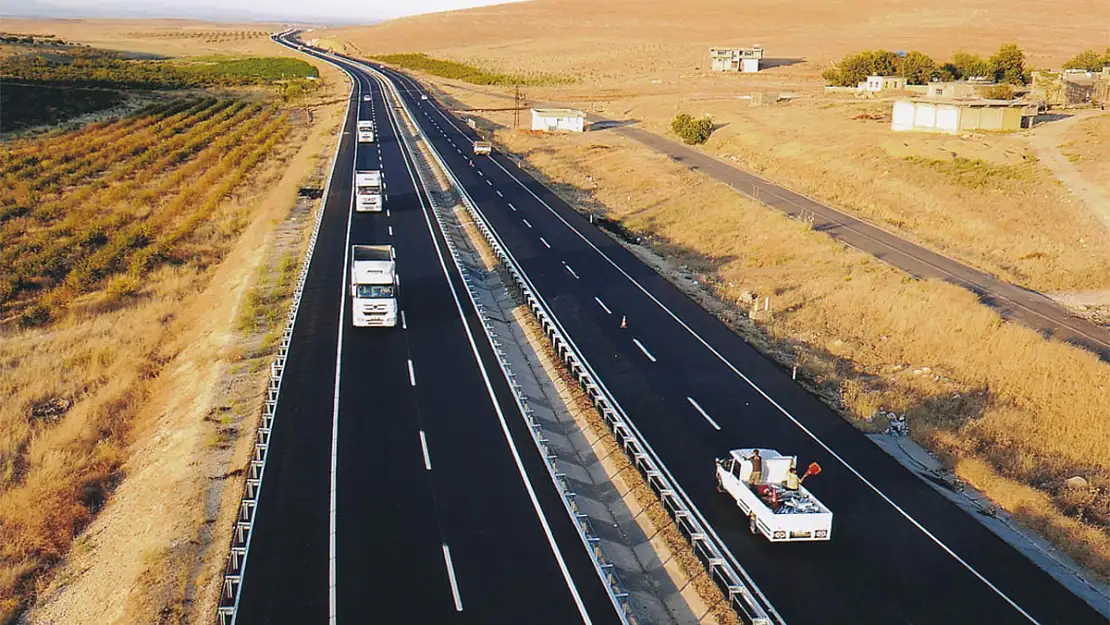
[890,99,1037,134]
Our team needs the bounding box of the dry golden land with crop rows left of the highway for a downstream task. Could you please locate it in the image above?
[0,20,346,624]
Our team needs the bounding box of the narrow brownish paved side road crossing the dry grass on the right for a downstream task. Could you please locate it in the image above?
[603,121,1110,361]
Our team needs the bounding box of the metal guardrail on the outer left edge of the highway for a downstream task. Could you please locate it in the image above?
[216,35,354,625]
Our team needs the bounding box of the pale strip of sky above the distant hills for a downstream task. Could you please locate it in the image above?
[0,0,523,21]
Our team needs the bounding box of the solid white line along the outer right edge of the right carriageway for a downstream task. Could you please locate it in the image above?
[463,100,1041,625]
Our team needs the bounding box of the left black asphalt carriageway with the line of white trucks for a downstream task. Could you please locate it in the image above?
[236,40,619,625]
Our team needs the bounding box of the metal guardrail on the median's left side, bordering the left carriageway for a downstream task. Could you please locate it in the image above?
[371,59,636,625]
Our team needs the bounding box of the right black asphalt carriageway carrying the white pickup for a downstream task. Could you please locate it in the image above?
[359,59,1107,625]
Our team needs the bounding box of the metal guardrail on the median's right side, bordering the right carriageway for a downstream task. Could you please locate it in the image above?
[368,59,773,625]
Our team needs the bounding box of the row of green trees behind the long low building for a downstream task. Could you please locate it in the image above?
[821,43,1031,87]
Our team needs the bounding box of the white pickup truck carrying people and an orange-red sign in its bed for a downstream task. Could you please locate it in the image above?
[717,448,833,543]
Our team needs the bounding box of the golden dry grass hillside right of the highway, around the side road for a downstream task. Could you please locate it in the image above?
[314,0,1110,578]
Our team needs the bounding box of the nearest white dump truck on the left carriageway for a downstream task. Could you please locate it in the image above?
[351,245,397,327]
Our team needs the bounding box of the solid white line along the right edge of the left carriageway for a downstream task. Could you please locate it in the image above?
[375,71,593,625]
